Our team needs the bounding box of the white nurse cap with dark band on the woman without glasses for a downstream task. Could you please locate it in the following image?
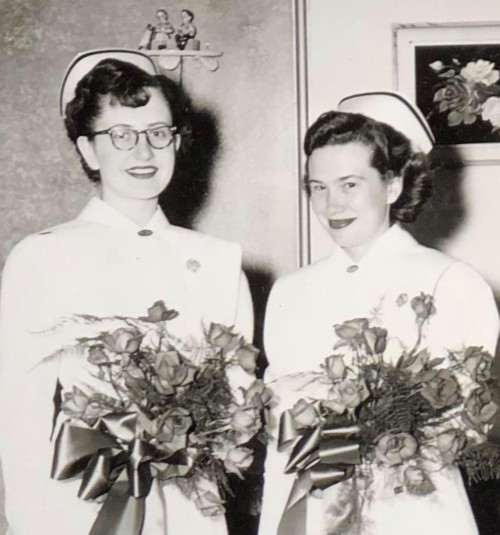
[338,91,435,154]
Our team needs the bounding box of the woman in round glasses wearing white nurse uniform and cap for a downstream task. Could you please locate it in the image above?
[0,50,253,535]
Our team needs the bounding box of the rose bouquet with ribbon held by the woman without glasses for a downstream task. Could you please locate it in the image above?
[278,293,500,533]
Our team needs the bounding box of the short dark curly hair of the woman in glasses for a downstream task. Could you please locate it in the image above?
[64,58,190,182]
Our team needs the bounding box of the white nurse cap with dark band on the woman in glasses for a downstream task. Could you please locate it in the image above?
[59,48,158,117]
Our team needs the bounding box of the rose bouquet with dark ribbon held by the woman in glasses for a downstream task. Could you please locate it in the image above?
[52,301,269,534]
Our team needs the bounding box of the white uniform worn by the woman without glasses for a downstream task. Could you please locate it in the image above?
[259,225,499,535]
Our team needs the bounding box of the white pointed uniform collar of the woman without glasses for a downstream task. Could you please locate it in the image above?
[330,223,418,269]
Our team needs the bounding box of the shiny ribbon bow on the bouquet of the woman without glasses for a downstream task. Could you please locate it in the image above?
[278,411,361,535]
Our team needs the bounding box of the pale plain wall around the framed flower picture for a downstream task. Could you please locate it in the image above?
[307,0,500,299]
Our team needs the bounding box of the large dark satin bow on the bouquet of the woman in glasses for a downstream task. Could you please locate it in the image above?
[51,412,188,535]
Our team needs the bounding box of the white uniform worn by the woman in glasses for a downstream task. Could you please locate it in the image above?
[0,198,253,535]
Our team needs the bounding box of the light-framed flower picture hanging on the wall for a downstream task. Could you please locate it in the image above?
[393,22,500,164]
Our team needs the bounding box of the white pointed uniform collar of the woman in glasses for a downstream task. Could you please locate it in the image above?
[77,197,170,231]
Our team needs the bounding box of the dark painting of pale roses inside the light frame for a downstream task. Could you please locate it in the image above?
[415,44,500,145]
